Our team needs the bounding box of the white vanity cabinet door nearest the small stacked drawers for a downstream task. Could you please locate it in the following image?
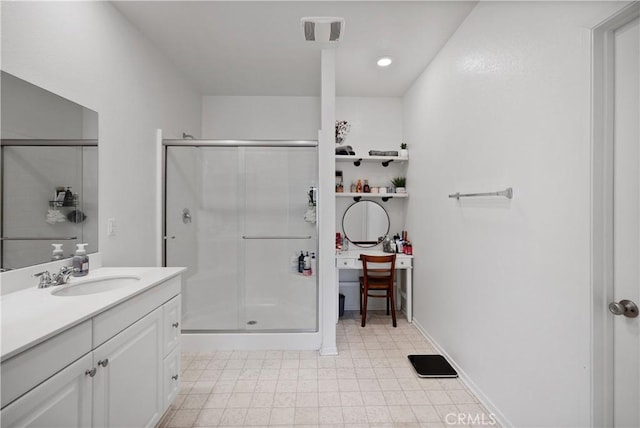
[93,308,163,427]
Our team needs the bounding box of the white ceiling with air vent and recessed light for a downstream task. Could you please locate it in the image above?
[114,1,476,96]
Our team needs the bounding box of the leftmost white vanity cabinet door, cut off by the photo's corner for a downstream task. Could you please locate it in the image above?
[0,354,93,428]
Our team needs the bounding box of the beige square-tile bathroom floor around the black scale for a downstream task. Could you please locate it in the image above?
[160,312,496,428]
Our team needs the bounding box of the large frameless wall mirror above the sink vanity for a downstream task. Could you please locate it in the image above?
[0,71,98,271]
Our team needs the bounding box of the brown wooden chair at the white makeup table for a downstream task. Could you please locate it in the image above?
[360,254,397,327]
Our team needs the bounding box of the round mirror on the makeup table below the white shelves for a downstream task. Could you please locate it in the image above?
[342,201,389,248]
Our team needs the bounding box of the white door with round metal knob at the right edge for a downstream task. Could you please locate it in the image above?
[610,15,640,427]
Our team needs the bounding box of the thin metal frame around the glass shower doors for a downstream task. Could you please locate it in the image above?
[161,139,320,335]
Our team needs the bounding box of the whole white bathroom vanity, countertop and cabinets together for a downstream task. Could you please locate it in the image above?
[0,268,184,427]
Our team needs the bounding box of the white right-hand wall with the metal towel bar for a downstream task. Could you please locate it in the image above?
[404,2,632,426]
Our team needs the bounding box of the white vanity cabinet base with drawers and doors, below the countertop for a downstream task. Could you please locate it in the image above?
[0,270,181,428]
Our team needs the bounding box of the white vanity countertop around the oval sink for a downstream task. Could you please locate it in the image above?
[0,267,186,361]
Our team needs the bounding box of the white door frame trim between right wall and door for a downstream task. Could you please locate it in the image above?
[590,1,640,427]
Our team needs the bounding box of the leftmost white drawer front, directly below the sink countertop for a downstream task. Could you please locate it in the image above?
[1,321,91,407]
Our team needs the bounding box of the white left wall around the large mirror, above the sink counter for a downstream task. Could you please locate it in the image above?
[2,2,201,266]
